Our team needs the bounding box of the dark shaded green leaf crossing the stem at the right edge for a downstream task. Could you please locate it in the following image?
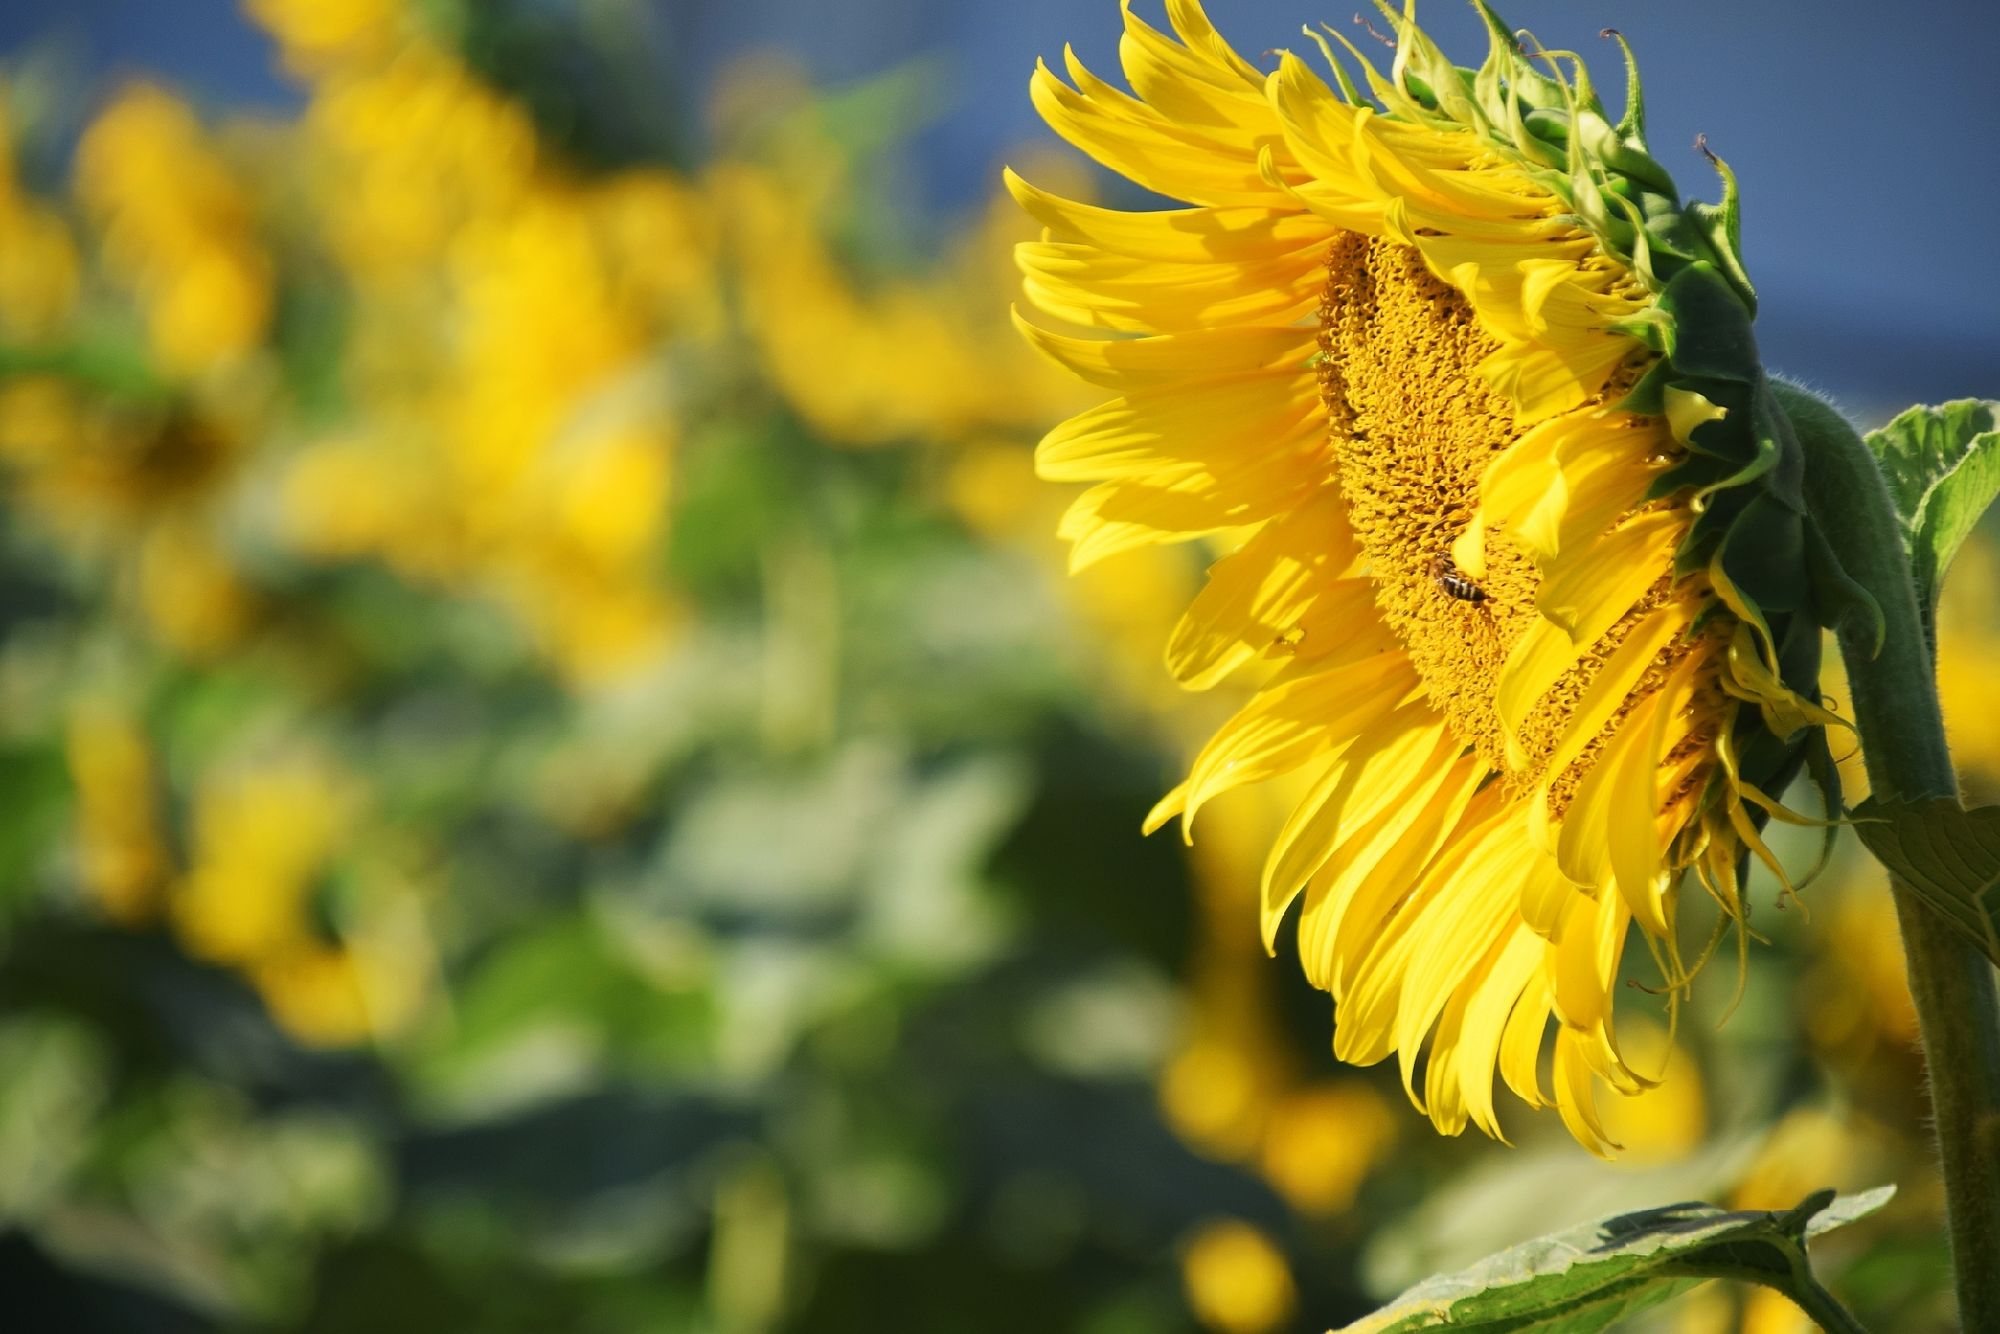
[1854,796,2000,964]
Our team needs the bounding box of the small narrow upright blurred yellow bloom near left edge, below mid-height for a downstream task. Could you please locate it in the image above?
[68,700,170,926]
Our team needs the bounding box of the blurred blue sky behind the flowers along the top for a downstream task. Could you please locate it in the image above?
[0,0,2000,414]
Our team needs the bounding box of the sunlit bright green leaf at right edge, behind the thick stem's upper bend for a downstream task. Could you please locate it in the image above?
[1866,398,2000,610]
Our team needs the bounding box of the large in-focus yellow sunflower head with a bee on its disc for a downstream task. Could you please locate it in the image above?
[1008,0,1862,1154]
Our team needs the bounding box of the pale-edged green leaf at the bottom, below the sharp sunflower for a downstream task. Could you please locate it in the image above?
[1342,1186,1896,1334]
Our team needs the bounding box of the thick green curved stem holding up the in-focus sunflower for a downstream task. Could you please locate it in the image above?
[1772,382,2000,1330]
